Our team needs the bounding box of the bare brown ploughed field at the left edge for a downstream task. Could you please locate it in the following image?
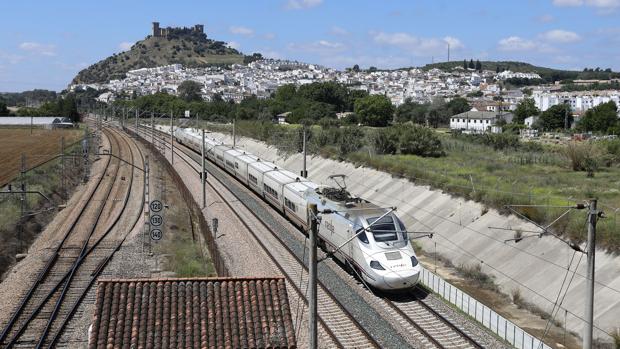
[0,128,82,186]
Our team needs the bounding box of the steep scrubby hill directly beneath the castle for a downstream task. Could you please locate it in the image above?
[71,28,251,84]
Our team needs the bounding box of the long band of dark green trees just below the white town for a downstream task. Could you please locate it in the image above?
[114,81,471,127]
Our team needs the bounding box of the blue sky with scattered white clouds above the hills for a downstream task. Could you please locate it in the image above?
[0,0,620,91]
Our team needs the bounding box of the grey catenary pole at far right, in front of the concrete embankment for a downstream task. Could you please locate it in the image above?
[583,199,599,349]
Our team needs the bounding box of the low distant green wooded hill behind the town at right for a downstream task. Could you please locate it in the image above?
[422,61,620,83]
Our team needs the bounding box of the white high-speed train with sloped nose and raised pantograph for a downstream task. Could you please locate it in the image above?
[170,127,420,290]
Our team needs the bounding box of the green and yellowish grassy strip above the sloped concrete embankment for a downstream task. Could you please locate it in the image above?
[174,120,620,253]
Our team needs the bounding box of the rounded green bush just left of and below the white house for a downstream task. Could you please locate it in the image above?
[400,125,445,157]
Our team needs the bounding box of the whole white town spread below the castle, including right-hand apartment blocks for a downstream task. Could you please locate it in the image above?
[76,59,620,133]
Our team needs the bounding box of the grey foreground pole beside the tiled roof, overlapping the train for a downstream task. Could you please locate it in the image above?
[308,204,319,349]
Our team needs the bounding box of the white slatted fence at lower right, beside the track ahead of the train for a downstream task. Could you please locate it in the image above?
[421,268,551,349]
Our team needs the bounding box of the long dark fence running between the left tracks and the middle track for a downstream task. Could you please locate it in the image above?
[124,128,229,276]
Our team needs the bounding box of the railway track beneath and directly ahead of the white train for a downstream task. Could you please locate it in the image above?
[138,123,496,348]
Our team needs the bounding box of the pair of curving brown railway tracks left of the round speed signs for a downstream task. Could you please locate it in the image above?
[0,125,143,348]
